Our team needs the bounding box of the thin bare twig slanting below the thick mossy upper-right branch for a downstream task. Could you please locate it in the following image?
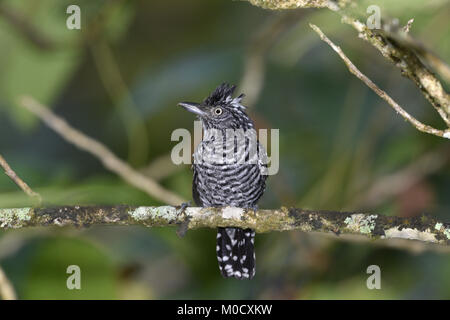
[309,24,450,139]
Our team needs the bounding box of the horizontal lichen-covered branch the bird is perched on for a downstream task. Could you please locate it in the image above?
[0,206,450,245]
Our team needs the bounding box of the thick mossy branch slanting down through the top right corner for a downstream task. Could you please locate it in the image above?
[247,0,450,132]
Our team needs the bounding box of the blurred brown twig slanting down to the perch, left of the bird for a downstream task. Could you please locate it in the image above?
[19,96,185,205]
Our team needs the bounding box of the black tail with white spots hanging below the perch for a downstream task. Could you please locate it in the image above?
[216,228,255,279]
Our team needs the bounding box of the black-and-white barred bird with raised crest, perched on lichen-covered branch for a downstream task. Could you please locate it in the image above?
[178,83,267,280]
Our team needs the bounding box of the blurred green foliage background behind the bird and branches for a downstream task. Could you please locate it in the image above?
[0,0,450,299]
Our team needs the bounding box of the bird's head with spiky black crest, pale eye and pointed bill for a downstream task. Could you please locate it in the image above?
[178,83,253,130]
